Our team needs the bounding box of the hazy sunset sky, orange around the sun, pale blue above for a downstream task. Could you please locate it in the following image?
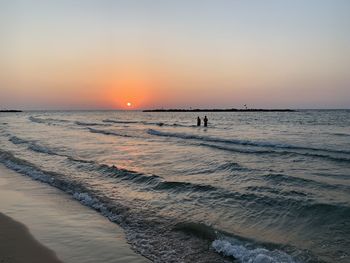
[0,0,350,110]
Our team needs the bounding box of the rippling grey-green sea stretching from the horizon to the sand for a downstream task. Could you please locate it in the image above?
[0,110,350,263]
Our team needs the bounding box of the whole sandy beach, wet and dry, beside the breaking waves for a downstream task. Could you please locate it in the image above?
[0,165,149,263]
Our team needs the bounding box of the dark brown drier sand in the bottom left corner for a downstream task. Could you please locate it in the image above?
[0,212,63,263]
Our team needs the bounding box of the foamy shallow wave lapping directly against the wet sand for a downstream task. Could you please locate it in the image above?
[0,150,232,263]
